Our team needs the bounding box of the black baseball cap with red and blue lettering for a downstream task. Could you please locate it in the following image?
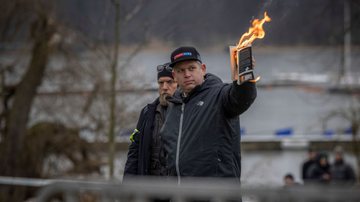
[170,46,201,67]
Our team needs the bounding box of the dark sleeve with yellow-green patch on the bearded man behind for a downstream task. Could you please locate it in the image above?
[124,108,146,177]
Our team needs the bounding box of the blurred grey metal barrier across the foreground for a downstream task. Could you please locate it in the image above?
[0,177,360,202]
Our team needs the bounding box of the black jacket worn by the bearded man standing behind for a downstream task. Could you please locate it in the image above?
[124,99,159,176]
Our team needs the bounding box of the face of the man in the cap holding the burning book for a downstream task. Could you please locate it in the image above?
[173,60,206,93]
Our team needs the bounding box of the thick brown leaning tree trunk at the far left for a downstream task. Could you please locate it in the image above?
[0,14,55,176]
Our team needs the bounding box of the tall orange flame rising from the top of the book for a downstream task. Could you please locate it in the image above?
[236,12,271,50]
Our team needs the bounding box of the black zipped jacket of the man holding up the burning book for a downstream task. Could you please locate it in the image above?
[160,74,256,180]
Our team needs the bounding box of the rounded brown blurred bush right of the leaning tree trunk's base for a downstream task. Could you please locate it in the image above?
[20,122,103,178]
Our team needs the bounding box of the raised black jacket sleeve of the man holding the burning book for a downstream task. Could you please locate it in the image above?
[222,81,257,117]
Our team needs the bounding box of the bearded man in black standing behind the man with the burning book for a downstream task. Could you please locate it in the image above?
[124,63,177,176]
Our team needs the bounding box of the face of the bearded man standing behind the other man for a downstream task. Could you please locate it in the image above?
[158,76,177,106]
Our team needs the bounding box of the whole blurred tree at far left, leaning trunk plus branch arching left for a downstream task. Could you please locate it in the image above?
[0,0,56,201]
